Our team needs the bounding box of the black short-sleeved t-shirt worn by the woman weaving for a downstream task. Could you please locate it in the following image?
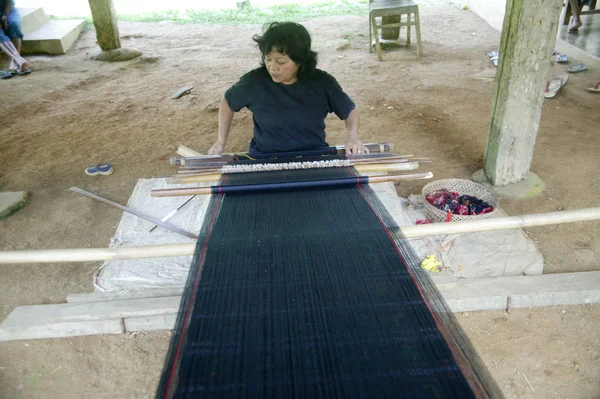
[225,67,355,154]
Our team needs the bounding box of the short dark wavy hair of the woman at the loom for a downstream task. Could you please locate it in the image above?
[252,22,317,80]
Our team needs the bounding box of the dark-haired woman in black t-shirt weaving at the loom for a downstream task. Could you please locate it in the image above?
[208,22,368,156]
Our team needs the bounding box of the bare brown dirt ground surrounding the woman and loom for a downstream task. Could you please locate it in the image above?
[0,2,600,399]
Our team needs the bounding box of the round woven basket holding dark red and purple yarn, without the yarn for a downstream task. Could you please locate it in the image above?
[421,179,499,223]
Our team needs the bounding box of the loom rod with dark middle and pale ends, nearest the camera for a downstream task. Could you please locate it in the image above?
[152,172,433,197]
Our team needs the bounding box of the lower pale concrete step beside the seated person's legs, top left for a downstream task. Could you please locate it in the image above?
[23,19,85,54]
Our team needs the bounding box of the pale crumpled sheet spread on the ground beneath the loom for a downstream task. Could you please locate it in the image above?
[95,179,543,292]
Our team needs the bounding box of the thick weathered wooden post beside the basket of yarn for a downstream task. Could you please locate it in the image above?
[483,0,563,186]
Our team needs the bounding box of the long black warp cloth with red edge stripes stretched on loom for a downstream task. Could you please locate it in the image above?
[157,169,502,398]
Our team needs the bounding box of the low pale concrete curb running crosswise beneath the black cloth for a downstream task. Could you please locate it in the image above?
[5,272,600,341]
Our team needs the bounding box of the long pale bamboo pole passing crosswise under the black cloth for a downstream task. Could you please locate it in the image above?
[0,207,600,264]
